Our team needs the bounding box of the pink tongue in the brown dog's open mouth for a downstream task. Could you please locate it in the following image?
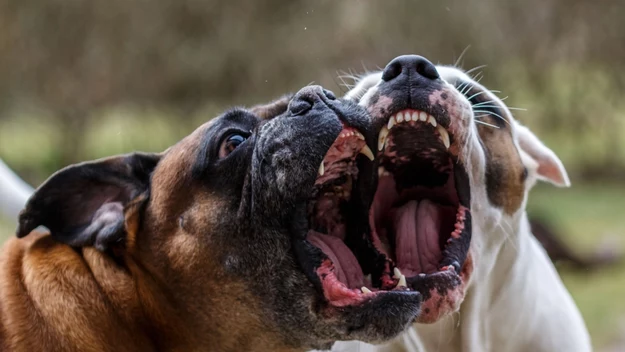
[307,230,364,288]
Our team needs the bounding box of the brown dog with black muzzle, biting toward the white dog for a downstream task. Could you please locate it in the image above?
[0,86,421,352]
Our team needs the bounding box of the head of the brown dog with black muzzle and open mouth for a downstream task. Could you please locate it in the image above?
[17,86,421,350]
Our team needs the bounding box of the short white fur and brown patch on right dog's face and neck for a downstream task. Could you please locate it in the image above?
[333,62,591,352]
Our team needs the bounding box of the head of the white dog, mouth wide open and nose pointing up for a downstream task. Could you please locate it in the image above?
[346,55,568,323]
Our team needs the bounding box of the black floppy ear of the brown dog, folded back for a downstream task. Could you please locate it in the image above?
[17,153,161,251]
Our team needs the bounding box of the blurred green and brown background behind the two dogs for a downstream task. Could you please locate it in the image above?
[0,0,625,351]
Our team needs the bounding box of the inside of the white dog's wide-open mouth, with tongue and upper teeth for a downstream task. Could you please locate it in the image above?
[369,111,469,280]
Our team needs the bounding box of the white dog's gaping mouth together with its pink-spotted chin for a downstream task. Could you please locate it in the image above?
[369,109,473,323]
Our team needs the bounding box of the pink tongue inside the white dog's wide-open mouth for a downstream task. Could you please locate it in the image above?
[393,199,442,277]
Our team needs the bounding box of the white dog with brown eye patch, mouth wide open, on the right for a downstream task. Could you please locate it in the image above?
[326,55,591,352]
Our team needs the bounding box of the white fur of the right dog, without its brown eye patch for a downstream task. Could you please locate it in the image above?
[322,67,591,352]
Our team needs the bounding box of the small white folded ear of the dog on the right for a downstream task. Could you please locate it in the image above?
[516,123,571,187]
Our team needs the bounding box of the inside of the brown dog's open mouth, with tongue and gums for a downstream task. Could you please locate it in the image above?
[307,127,408,307]
